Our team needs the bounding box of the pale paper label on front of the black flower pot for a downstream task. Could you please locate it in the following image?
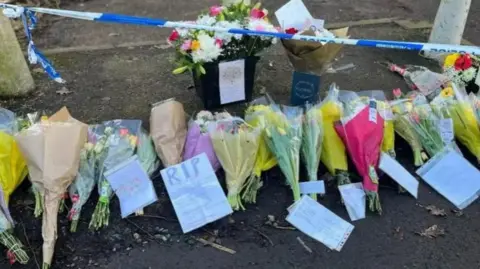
[218,59,245,105]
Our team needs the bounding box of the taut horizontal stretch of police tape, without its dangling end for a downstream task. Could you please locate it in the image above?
[0,4,480,81]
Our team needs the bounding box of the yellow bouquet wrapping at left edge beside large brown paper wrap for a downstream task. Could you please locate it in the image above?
[0,132,28,205]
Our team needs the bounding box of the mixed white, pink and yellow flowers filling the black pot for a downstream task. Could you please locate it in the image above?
[168,0,277,76]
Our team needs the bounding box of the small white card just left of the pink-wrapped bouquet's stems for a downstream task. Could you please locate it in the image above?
[338,183,367,221]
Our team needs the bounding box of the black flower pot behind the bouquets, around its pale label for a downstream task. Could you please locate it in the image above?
[192,56,260,110]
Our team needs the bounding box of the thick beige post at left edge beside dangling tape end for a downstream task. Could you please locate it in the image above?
[0,13,35,96]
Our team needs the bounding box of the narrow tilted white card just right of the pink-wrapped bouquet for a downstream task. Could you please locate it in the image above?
[378,152,419,198]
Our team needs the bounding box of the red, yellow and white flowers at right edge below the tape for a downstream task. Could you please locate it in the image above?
[443,53,480,93]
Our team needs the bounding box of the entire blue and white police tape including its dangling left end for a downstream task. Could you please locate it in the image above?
[0,3,480,82]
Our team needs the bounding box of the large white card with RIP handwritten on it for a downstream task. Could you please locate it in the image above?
[161,153,233,233]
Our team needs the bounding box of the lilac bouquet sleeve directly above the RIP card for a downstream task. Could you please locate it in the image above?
[183,116,220,171]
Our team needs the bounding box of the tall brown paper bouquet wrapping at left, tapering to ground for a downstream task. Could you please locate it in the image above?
[16,107,88,265]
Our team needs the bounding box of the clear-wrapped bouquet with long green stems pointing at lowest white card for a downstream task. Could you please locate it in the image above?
[265,105,303,202]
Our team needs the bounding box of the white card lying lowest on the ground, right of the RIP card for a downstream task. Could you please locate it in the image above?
[287,195,354,251]
